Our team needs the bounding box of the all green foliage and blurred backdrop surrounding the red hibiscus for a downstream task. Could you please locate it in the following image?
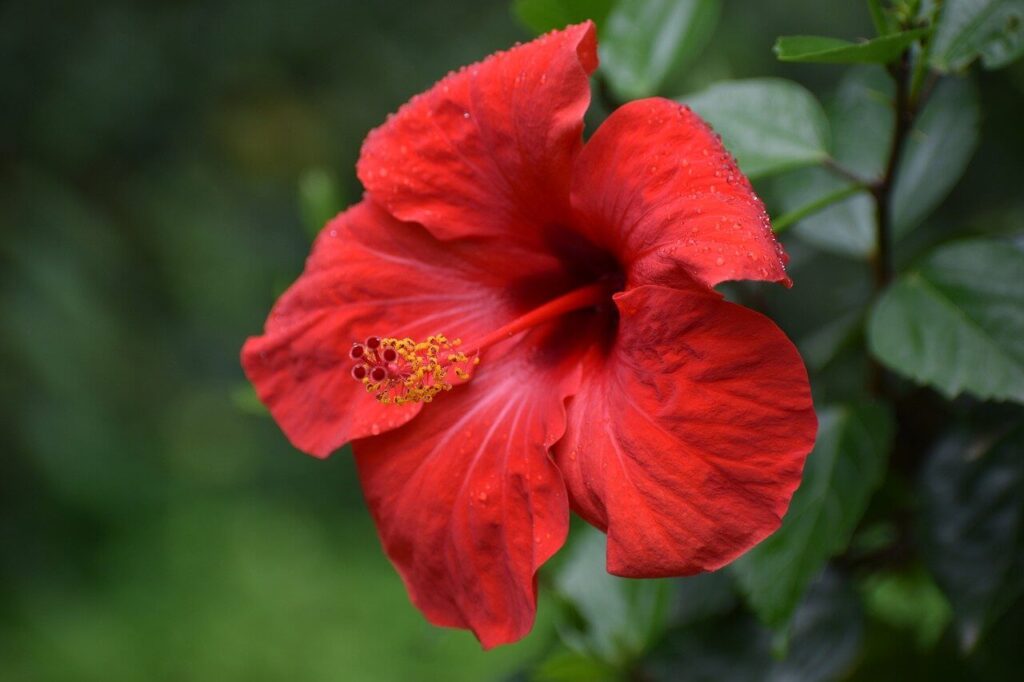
[0,0,1024,681]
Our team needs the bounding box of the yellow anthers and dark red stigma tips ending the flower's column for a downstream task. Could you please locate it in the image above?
[348,334,480,404]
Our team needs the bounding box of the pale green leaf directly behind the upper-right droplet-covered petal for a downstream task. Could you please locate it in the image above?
[682,78,828,177]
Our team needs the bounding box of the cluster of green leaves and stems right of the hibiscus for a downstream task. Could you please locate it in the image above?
[516,0,1024,680]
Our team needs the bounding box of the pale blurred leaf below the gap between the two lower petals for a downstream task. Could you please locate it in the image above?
[555,526,672,667]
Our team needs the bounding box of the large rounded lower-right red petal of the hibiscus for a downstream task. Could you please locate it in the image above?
[556,285,817,578]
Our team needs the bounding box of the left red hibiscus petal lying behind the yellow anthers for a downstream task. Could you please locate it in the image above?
[242,202,557,457]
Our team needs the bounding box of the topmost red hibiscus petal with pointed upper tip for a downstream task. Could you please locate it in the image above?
[357,22,597,244]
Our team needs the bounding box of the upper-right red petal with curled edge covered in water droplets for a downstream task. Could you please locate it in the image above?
[572,98,790,286]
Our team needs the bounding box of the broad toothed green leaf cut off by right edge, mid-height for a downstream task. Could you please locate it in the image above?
[867,240,1024,402]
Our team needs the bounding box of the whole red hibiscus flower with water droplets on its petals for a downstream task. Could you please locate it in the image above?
[242,23,816,647]
